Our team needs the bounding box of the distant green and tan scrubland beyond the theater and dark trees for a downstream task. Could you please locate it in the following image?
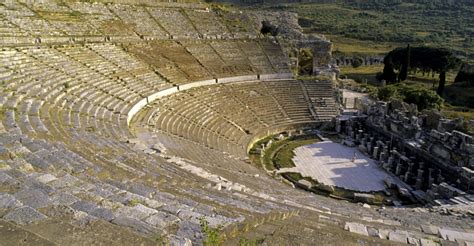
[254,1,474,60]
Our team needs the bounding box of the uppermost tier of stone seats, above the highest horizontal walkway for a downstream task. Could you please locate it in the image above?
[0,1,258,42]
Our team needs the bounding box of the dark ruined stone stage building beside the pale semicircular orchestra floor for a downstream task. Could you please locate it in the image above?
[337,99,474,198]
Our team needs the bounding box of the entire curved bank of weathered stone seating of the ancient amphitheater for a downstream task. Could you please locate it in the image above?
[0,0,474,245]
